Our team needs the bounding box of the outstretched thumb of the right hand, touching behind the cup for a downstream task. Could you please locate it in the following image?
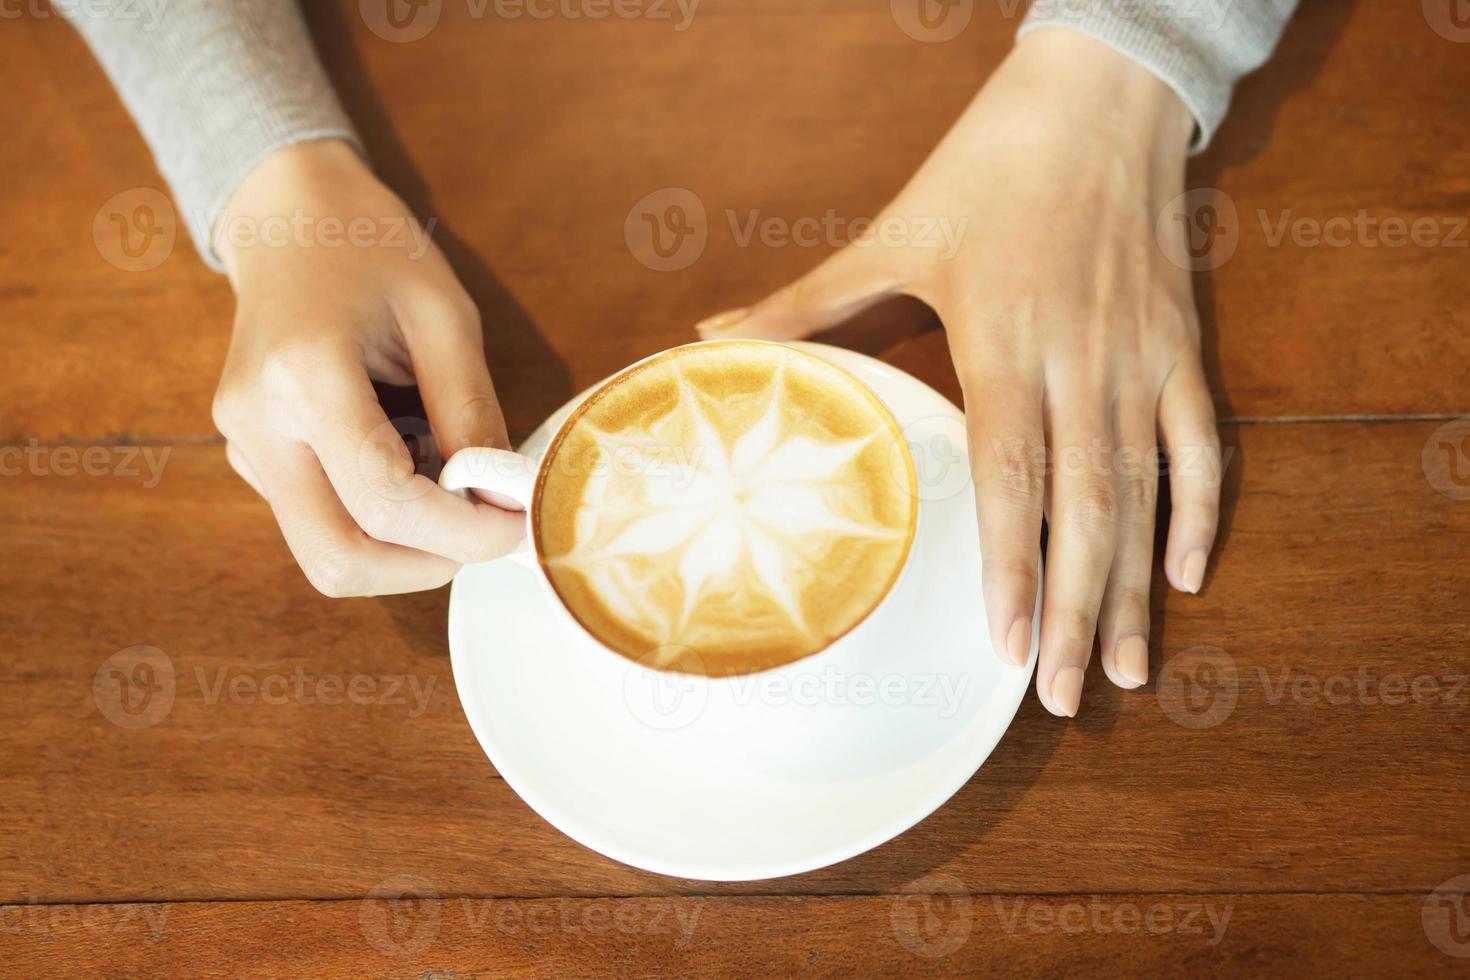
[694,241,901,341]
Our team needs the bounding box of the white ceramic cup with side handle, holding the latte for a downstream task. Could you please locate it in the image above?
[440,341,923,727]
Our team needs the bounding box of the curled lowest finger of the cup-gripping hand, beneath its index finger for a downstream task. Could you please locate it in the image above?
[241,444,459,597]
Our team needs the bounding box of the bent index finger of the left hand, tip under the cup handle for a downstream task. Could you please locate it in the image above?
[306,372,525,564]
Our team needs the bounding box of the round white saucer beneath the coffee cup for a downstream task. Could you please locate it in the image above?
[448,344,1039,882]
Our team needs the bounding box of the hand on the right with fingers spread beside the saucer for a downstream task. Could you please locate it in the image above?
[698,29,1220,716]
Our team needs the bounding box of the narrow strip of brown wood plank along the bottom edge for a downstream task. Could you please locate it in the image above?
[0,884,1470,977]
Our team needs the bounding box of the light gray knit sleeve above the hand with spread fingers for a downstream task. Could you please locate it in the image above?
[1017,0,1297,153]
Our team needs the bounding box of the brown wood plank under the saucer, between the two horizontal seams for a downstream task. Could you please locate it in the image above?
[0,422,1470,902]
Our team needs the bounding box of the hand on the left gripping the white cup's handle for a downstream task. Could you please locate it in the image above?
[213,141,525,595]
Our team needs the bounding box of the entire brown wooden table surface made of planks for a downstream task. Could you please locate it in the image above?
[0,0,1470,976]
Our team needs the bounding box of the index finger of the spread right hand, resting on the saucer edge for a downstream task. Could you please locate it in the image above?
[964,375,1047,667]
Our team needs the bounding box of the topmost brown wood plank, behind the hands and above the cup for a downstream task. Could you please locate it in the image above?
[0,0,1470,439]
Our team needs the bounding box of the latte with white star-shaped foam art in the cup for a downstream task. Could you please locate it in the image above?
[532,341,917,676]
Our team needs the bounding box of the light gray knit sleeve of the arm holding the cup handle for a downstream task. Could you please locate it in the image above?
[54,0,362,269]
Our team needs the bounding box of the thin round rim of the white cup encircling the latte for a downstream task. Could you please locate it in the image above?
[526,338,922,685]
